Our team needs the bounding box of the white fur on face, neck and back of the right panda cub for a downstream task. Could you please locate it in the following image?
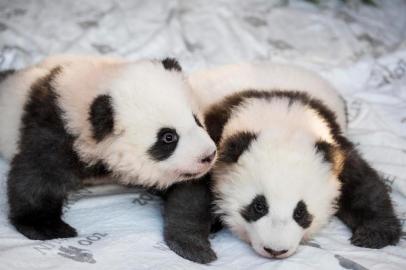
[190,63,345,258]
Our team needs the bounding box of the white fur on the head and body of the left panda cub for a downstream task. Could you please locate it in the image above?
[0,56,215,187]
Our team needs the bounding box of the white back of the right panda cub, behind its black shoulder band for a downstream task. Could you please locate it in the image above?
[189,63,346,131]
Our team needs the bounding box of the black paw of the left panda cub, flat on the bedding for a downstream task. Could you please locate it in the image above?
[14,220,77,240]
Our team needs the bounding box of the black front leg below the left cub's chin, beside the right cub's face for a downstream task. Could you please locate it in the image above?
[164,176,217,263]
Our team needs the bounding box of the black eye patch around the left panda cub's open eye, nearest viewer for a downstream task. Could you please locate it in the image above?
[148,128,179,161]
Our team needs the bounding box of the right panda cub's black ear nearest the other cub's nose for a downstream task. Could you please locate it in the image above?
[220,131,257,163]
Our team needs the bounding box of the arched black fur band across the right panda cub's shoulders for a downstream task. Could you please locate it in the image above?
[204,90,341,144]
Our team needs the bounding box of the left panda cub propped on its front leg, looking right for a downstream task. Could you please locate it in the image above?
[0,56,216,249]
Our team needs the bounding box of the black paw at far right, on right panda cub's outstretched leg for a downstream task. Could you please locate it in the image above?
[351,222,401,249]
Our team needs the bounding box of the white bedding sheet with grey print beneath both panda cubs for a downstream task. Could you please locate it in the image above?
[0,0,406,270]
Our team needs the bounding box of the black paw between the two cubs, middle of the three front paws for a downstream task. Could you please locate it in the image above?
[165,232,217,264]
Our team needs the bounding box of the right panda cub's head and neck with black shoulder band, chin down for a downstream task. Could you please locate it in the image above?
[205,92,341,258]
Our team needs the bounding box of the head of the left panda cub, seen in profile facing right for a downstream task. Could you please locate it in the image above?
[68,59,216,188]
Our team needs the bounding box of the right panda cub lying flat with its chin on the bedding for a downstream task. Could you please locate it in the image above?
[189,63,400,258]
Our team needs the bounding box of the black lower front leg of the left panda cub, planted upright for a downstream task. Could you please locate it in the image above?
[8,143,78,240]
